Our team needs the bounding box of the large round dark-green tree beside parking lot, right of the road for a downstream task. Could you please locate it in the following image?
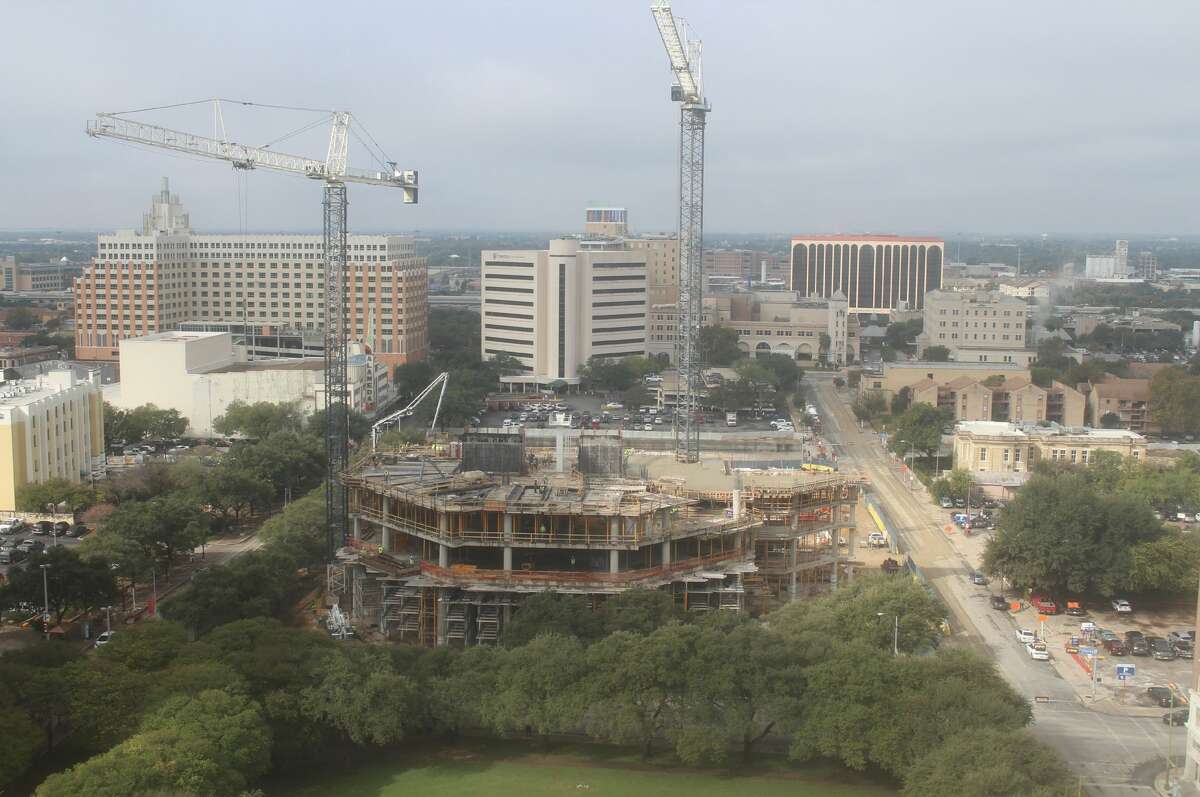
[983,472,1163,595]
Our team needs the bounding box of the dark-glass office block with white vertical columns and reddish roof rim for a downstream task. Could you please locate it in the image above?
[791,235,946,313]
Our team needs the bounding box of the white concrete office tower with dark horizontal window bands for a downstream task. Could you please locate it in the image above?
[480,238,647,386]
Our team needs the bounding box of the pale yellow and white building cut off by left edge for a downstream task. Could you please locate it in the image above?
[0,370,104,510]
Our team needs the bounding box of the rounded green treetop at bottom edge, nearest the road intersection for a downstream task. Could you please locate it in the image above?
[904,727,1075,797]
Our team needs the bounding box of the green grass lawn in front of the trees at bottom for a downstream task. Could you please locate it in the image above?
[265,742,898,797]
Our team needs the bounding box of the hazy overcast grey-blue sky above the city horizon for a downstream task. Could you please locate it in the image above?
[0,0,1200,234]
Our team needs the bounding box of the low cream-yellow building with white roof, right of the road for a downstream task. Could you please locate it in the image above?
[954,421,1146,473]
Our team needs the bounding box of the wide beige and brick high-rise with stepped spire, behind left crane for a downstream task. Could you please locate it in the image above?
[76,180,428,368]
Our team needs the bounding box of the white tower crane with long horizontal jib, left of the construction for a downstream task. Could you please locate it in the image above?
[85,100,418,556]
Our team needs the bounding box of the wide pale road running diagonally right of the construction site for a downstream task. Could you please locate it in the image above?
[805,374,1187,797]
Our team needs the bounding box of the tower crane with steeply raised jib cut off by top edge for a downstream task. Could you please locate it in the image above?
[650,0,710,462]
